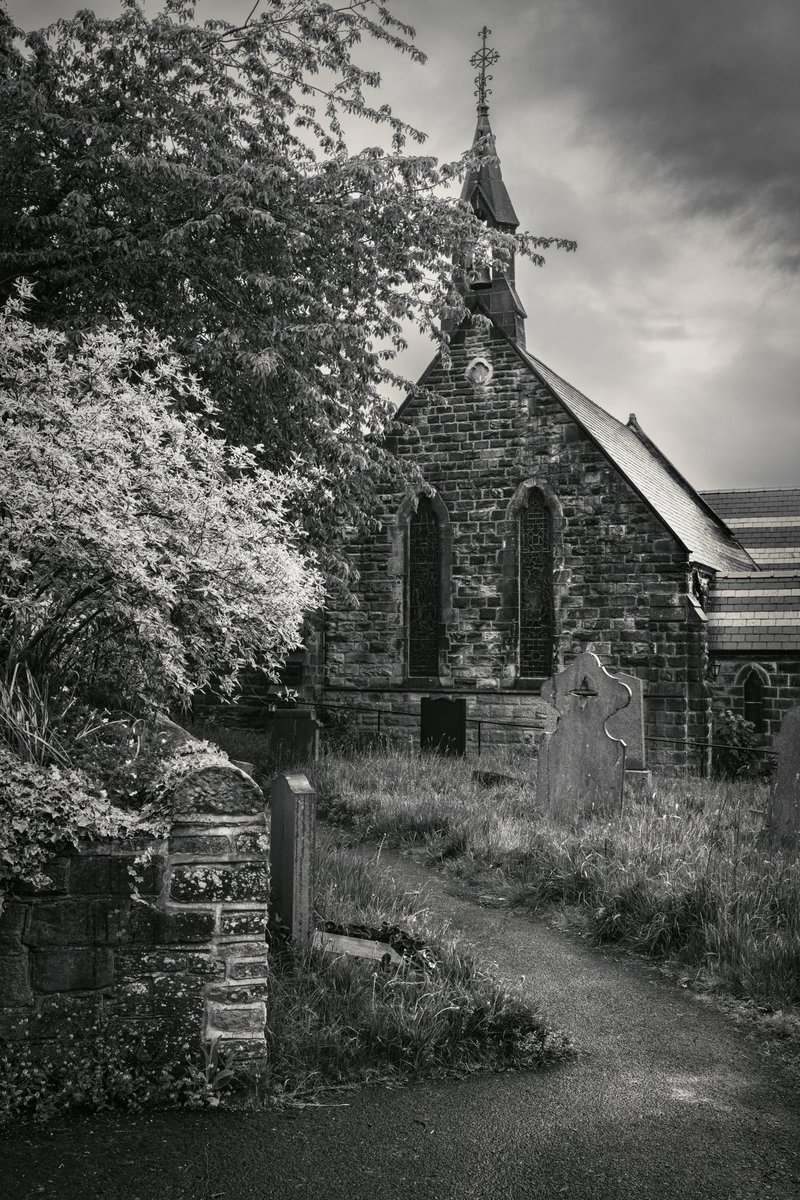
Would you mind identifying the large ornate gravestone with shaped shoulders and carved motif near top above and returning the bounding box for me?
[536,652,631,821]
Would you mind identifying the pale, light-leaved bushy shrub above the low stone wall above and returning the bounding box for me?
[0,285,321,704]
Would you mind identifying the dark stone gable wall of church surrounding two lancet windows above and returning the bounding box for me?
[315,319,710,769]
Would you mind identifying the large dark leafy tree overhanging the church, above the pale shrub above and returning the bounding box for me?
[0,0,569,580]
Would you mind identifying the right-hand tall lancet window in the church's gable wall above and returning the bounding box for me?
[517,488,554,677]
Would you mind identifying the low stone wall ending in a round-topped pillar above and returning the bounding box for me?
[0,764,270,1060]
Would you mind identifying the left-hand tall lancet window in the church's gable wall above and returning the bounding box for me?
[408,496,441,676]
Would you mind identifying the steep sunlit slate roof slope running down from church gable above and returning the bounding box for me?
[517,347,754,572]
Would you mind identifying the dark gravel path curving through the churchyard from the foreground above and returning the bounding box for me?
[0,835,800,1200]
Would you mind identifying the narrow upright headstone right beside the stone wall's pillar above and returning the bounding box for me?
[270,775,317,946]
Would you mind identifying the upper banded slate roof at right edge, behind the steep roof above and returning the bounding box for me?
[703,487,800,571]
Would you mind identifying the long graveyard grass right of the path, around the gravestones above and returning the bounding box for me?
[308,749,800,1012]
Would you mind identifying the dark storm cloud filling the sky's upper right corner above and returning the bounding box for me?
[519,0,800,269]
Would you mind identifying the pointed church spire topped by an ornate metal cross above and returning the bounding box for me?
[461,25,525,346]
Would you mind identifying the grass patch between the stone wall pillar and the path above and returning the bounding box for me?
[260,838,571,1105]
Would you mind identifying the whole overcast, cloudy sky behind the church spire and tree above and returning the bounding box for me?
[8,0,800,490]
